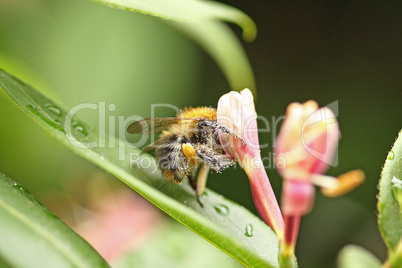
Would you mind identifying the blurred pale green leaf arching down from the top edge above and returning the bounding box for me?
[93,0,257,93]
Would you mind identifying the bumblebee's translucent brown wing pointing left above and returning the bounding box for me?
[127,117,200,135]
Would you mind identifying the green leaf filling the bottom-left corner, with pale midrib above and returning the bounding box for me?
[0,173,109,268]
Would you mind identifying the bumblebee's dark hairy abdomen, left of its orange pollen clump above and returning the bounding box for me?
[155,135,191,182]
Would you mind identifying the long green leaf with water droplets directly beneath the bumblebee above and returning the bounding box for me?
[0,70,278,267]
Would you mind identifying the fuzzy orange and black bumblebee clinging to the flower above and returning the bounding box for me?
[127,107,244,205]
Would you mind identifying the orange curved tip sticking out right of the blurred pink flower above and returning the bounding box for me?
[321,169,366,197]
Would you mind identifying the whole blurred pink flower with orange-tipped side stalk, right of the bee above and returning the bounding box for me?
[275,101,364,258]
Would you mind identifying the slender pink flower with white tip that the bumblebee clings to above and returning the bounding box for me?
[217,89,284,239]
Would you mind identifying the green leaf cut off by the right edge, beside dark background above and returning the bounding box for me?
[377,131,402,253]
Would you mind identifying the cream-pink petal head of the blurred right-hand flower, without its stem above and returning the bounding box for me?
[275,101,340,182]
